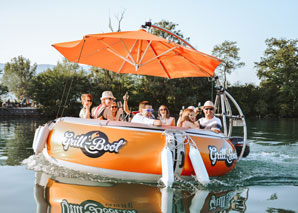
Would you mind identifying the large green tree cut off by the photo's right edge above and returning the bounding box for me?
[255,38,298,117]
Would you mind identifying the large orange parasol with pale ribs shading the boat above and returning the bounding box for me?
[53,27,220,78]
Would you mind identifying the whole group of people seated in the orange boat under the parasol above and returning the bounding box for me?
[80,91,222,133]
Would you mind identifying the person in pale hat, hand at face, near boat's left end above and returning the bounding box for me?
[92,91,116,120]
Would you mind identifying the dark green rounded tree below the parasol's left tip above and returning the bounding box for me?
[28,59,90,117]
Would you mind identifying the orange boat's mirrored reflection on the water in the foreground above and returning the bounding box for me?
[34,172,248,213]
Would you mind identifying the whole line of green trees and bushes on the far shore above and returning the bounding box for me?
[0,21,298,118]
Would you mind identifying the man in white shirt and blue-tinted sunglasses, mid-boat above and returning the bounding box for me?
[131,101,161,126]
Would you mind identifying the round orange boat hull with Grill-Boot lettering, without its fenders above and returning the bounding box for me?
[44,119,237,181]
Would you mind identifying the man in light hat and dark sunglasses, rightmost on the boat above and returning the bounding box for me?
[199,101,222,133]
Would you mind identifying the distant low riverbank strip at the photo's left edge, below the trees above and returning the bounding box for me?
[0,107,40,117]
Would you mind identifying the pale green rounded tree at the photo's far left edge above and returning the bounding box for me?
[2,56,37,99]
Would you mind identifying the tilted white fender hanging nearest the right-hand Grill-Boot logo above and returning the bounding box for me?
[189,146,210,185]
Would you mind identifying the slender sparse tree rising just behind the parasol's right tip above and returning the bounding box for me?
[212,41,245,88]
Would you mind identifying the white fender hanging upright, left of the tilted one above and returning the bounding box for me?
[161,147,174,187]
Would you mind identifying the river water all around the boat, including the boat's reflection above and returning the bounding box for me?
[0,118,298,213]
